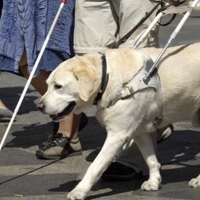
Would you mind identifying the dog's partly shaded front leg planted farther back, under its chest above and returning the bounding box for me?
[135,133,162,191]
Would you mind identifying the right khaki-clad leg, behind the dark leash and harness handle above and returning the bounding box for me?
[117,0,159,48]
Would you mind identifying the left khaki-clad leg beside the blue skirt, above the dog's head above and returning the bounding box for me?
[74,0,118,55]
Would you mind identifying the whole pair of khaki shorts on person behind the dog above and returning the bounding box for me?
[74,0,158,54]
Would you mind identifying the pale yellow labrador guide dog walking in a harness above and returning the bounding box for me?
[38,43,200,200]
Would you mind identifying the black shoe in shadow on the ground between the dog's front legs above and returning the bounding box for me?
[101,162,138,181]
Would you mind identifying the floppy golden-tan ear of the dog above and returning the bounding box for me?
[74,68,99,102]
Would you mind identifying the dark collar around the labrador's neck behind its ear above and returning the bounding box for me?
[93,54,109,105]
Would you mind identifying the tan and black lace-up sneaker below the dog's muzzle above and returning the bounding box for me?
[35,133,82,160]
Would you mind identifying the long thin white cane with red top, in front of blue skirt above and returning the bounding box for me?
[0,0,67,151]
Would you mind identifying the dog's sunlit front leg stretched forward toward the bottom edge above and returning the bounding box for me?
[67,133,126,200]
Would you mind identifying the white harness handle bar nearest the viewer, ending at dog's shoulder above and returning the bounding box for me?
[143,0,199,82]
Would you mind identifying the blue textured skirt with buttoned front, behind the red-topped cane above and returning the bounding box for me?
[0,0,75,75]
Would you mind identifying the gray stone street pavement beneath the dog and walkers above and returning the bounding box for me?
[0,7,200,200]
